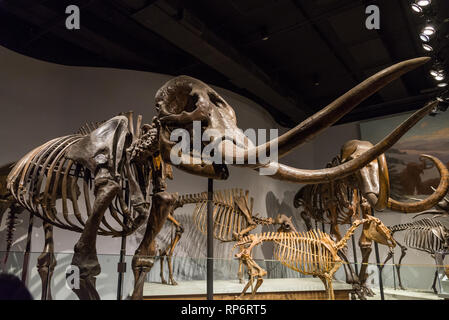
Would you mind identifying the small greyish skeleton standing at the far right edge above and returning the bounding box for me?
[383,218,449,293]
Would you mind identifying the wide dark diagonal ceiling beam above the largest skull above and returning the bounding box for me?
[133,0,312,123]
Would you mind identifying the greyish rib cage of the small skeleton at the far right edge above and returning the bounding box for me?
[389,218,447,254]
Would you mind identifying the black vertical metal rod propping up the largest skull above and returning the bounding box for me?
[207,178,214,300]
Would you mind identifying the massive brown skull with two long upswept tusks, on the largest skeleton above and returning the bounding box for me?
[156,58,436,183]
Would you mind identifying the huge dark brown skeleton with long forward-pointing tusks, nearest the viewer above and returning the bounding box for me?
[0,58,440,299]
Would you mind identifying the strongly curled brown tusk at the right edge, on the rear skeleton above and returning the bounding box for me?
[388,155,449,213]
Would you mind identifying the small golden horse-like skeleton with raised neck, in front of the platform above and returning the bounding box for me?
[235,212,395,300]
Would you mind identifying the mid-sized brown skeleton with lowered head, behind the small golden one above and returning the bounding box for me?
[160,189,295,284]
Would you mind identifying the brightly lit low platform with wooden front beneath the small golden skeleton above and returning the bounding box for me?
[143,278,352,300]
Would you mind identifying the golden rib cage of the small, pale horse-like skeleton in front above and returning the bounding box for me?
[237,230,336,276]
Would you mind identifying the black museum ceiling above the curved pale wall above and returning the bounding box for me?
[0,0,449,126]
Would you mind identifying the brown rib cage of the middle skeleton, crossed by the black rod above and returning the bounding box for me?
[179,189,266,242]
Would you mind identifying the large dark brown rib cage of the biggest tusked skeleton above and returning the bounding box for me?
[8,131,145,236]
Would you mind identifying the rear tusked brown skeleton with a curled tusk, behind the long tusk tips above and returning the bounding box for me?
[294,137,449,299]
